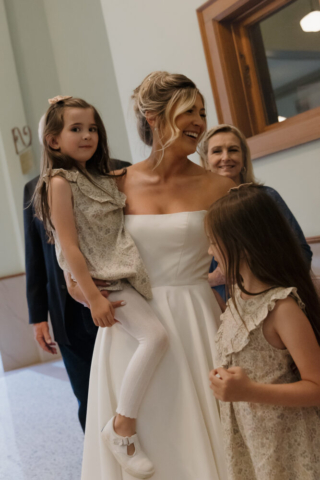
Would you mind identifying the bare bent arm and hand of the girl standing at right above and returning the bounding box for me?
[210,298,320,407]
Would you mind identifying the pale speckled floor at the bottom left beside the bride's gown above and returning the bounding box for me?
[0,361,83,480]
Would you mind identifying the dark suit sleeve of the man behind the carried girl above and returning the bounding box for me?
[23,184,48,323]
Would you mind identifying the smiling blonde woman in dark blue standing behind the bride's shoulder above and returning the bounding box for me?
[199,124,312,305]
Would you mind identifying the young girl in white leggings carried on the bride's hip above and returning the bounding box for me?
[35,97,167,478]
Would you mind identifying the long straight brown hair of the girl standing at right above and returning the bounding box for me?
[205,185,320,344]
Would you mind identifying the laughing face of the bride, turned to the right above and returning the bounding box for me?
[164,94,207,156]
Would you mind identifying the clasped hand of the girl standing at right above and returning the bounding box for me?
[209,367,254,402]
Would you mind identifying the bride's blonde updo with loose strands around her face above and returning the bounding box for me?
[132,71,204,161]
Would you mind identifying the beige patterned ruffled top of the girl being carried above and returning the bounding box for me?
[52,168,152,299]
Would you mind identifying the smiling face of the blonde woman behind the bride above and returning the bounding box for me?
[207,132,244,185]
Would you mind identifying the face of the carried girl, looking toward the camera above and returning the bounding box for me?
[51,107,99,167]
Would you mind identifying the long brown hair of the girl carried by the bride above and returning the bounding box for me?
[32,97,121,243]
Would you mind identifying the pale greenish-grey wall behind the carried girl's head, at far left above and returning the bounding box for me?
[0,0,131,277]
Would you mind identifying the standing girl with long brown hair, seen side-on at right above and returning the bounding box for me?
[206,185,320,480]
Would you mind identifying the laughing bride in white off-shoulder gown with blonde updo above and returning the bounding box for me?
[82,72,233,480]
